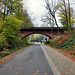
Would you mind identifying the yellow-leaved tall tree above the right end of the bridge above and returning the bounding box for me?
[58,0,75,30]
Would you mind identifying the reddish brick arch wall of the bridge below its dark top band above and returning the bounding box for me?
[20,31,65,38]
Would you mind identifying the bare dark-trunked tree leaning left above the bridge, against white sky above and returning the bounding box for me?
[45,0,60,34]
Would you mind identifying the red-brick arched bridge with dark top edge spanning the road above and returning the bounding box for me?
[20,27,67,38]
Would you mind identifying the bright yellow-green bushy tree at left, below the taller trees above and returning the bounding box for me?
[0,15,22,48]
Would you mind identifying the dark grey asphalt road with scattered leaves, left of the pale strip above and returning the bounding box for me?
[0,44,54,75]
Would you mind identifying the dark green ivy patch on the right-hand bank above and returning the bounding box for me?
[55,31,75,50]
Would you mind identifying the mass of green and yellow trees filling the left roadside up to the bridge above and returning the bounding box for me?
[0,0,33,50]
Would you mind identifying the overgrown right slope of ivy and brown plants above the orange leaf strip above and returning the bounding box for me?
[54,30,75,55]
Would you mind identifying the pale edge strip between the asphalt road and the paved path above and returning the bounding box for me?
[41,45,61,75]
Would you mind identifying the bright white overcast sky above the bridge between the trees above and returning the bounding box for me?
[23,0,75,27]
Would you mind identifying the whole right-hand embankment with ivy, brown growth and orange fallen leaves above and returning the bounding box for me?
[45,29,75,61]
